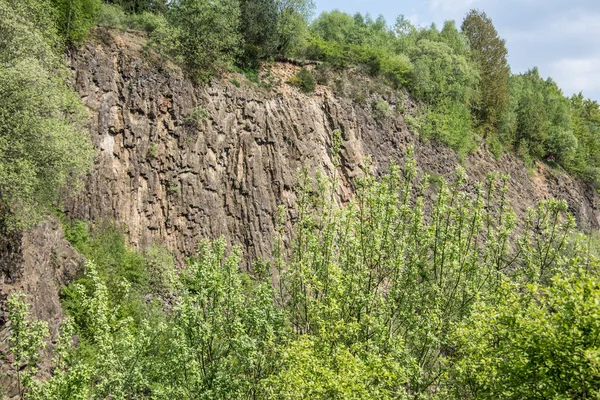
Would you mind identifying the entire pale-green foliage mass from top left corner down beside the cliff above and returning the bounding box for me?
[0,0,93,229]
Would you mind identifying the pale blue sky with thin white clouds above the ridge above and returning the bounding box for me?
[314,0,600,101]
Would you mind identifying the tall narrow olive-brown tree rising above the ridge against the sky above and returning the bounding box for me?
[461,10,510,132]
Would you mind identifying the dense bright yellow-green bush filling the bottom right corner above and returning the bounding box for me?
[451,271,600,399]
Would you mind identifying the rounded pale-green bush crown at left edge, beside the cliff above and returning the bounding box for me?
[0,59,94,228]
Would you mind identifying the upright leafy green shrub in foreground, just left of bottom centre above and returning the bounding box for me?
[157,240,282,399]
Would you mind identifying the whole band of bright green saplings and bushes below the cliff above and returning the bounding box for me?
[11,155,600,399]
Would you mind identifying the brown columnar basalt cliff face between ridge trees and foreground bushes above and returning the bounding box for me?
[67,31,600,266]
